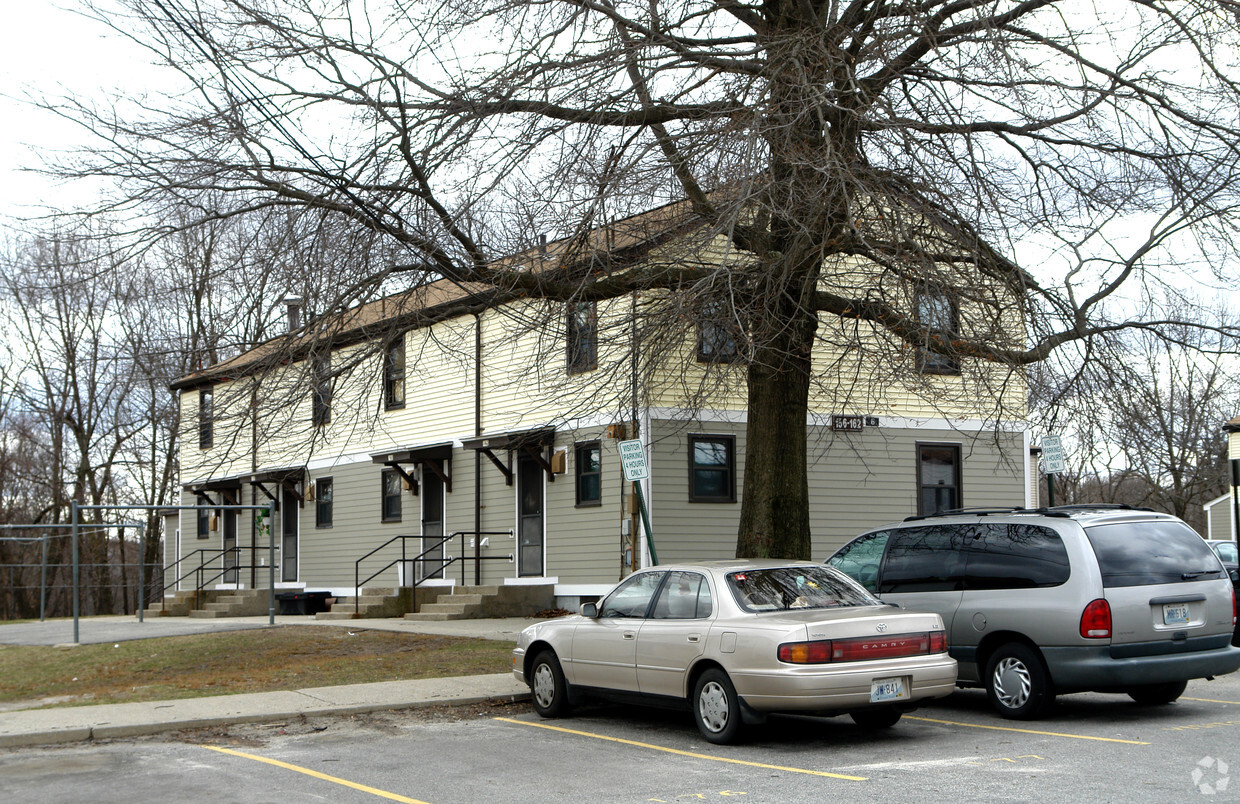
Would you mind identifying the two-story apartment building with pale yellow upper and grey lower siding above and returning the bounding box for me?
[167,202,1037,605]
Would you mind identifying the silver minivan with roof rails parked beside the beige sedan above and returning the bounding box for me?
[827,505,1240,720]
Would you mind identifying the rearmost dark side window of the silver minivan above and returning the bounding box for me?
[965,525,1070,589]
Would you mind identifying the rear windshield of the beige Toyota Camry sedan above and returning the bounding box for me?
[728,567,883,612]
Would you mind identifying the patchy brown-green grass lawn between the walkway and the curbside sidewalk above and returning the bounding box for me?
[0,625,512,706]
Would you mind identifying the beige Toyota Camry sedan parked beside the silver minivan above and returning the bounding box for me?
[512,560,956,743]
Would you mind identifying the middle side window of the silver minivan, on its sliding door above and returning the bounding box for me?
[878,525,967,594]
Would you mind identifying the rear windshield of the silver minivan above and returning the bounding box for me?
[1085,521,1223,587]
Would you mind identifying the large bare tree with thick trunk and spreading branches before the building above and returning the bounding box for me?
[61,0,1240,557]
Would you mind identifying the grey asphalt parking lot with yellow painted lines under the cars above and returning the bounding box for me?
[0,675,1240,804]
